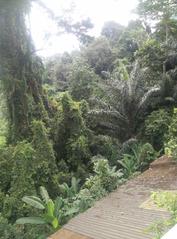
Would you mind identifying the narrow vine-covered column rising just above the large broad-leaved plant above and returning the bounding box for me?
[32,121,58,196]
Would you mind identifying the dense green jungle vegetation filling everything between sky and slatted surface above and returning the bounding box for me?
[0,0,177,239]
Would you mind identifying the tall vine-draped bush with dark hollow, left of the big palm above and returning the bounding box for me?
[52,93,91,181]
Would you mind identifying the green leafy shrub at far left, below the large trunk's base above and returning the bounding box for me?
[2,141,36,222]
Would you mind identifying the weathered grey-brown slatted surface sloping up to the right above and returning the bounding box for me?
[50,156,177,239]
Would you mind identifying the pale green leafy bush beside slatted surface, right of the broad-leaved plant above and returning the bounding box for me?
[54,157,123,224]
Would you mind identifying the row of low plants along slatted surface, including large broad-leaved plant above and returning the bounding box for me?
[17,157,123,228]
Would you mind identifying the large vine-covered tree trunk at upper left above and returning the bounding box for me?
[0,0,47,142]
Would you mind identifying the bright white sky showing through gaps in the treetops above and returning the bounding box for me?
[30,0,137,57]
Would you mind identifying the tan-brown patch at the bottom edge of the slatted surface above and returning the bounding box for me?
[48,229,91,239]
